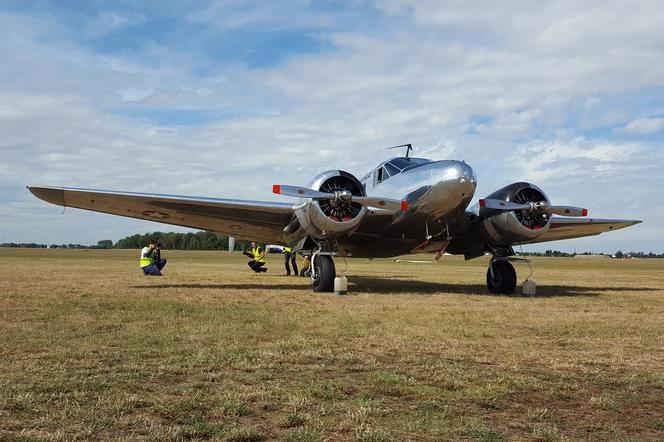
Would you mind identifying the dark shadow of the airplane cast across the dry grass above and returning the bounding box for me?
[131,275,658,297]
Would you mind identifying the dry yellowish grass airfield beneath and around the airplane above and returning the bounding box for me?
[0,249,664,441]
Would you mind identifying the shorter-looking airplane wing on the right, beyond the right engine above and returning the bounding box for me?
[521,217,641,244]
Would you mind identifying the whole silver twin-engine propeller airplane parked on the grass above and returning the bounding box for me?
[28,145,640,293]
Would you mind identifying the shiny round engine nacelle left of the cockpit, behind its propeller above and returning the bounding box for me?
[295,170,367,240]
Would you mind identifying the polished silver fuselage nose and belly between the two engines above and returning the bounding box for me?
[339,160,477,257]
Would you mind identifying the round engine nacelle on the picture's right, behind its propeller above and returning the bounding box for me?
[479,183,551,246]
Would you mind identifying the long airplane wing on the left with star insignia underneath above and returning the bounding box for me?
[28,186,294,243]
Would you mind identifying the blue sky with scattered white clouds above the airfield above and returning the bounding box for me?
[0,0,664,252]
